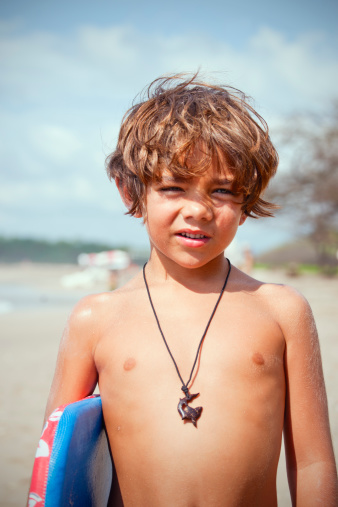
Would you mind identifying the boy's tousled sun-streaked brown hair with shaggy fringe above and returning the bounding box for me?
[106,74,278,218]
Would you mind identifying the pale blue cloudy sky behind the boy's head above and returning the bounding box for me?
[0,0,338,253]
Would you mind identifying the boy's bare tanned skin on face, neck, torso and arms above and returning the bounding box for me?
[46,168,337,507]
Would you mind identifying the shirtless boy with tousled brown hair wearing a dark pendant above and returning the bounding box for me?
[46,76,337,507]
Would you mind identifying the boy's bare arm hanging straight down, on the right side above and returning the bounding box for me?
[278,287,338,507]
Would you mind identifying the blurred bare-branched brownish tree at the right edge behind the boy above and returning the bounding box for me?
[267,102,338,266]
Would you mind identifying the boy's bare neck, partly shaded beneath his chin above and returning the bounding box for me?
[146,249,229,293]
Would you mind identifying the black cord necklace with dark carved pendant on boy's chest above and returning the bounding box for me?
[143,259,231,427]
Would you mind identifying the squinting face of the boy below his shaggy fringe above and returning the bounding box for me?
[145,167,246,268]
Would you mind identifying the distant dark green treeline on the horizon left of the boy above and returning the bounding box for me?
[0,237,126,264]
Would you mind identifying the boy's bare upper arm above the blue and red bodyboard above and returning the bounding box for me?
[45,296,99,421]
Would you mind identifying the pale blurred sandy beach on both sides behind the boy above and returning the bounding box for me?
[0,264,338,507]
